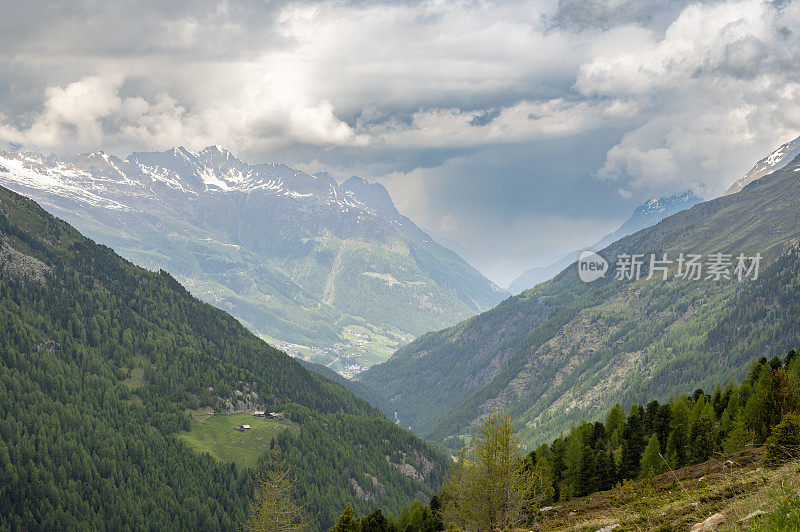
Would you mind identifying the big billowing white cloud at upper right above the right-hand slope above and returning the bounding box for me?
[576,0,800,197]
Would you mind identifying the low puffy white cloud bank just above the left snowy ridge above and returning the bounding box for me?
[0,75,368,150]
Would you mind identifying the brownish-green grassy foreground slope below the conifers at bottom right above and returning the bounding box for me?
[533,449,800,532]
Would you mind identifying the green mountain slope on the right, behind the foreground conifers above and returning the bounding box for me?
[362,153,800,445]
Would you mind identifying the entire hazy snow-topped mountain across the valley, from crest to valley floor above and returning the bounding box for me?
[0,146,507,372]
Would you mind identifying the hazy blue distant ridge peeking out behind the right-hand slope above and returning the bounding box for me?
[508,190,701,294]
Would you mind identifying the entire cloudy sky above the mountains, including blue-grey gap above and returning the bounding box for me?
[0,0,800,286]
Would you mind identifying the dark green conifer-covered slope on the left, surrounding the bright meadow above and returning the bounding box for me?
[0,188,444,530]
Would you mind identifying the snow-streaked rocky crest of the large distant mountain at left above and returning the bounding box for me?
[0,146,400,217]
